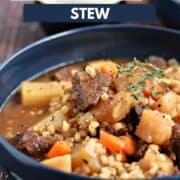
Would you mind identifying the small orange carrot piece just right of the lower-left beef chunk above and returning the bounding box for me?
[47,141,71,158]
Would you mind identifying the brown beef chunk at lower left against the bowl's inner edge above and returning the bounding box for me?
[11,130,56,159]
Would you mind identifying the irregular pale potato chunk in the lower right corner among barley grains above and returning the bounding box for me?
[139,145,174,175]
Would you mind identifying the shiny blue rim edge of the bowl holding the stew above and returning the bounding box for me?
[0,24,180,180]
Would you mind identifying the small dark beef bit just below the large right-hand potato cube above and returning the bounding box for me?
[133,140,148,161]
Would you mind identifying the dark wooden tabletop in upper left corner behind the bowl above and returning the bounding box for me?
[0,0,45,63]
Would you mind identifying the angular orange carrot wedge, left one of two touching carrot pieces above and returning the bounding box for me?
[100,130,125,153]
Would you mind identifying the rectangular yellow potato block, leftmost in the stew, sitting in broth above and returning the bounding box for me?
[21,81,63,107]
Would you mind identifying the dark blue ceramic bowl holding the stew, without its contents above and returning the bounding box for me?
[0,25,180,180]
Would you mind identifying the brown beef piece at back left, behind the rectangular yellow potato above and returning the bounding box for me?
[51,65,84,81]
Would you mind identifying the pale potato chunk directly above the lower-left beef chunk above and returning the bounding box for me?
[33,111,66,134]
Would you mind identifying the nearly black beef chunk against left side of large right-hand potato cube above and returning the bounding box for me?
[125,104,148,132]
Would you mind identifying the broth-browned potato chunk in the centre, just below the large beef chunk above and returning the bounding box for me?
[92,92,132,123]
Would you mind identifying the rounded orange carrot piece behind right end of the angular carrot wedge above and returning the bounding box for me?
[119,136,136,156]
